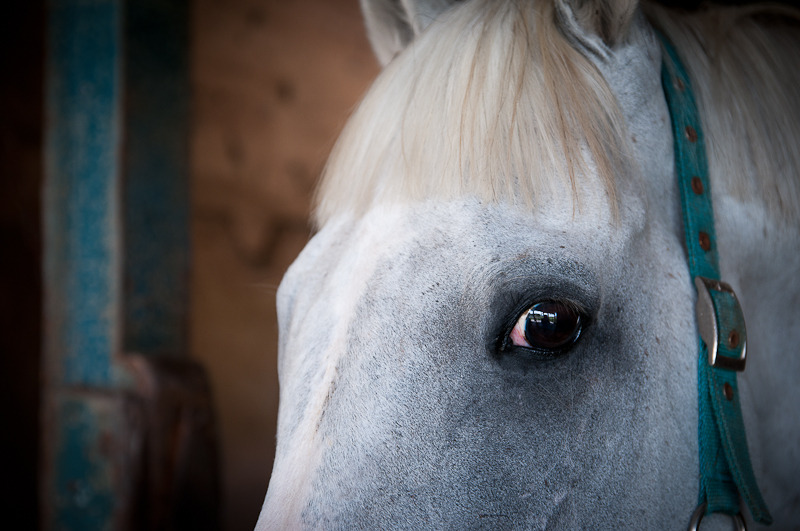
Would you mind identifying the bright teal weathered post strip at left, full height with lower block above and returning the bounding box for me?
[41,0,122,529]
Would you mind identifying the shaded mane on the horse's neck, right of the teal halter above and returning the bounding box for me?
[646,4,800,221]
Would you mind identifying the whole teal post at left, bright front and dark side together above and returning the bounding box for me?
[40,0,208,530]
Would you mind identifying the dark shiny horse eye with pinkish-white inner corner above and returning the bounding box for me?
[509,301,583,352]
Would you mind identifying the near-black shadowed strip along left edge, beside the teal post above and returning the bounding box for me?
[0,1,44,529]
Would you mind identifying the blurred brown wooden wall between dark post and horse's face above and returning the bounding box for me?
[190,0,378,530]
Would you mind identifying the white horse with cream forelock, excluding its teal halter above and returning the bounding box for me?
[257,0,800,529]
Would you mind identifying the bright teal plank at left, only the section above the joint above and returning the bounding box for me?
[44,0,122,387]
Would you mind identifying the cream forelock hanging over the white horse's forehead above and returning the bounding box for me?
[316,0,629,225]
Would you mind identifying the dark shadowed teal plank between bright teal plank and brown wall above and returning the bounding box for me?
[123,0,191,355]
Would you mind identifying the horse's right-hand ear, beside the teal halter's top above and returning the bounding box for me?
[556,0,639,55]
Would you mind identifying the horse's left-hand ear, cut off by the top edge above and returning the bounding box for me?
[360,0,458,65]
